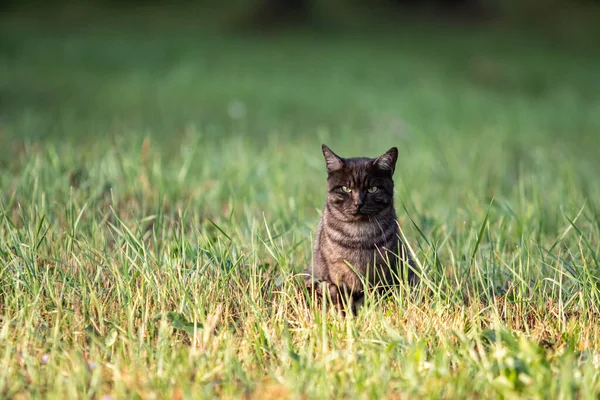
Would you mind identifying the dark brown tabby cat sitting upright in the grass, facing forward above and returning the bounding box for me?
[305,145,416,306]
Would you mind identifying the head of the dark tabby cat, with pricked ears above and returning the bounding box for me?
[322,145,398,220]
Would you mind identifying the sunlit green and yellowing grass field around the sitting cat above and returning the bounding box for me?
[0,7,600,399]
